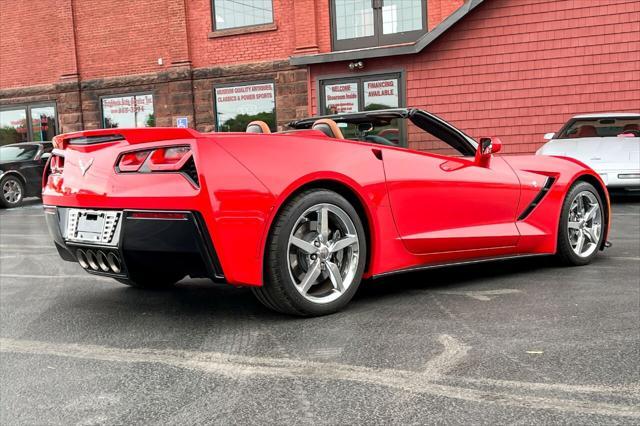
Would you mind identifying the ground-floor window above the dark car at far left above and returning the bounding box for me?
[0,104,59,145]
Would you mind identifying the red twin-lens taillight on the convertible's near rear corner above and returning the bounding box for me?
[116,145,199,187]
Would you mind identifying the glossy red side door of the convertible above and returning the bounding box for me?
[384,111,520,254]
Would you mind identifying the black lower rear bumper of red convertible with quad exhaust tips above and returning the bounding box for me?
[45,206,225,282]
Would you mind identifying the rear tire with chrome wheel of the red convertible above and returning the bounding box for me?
[252,189,367,316]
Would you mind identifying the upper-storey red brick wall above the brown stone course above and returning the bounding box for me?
[0,0,463,88]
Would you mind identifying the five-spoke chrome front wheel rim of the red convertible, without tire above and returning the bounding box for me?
[567,191,602,257]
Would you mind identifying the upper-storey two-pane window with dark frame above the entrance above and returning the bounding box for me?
[331,0,427,50]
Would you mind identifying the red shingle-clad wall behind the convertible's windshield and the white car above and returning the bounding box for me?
[311,0,640,153]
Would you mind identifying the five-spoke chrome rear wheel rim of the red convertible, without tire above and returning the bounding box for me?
[287,203,360,304]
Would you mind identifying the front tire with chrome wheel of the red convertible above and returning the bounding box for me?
[556,181,606,266]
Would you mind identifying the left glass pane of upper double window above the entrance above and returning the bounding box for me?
[335,0,374,40]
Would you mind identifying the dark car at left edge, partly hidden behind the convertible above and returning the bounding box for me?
[0,142,53,207]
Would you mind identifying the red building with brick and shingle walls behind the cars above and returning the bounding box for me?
[0,0,640,152]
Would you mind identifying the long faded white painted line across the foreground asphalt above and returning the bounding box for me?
[0,336,640,418]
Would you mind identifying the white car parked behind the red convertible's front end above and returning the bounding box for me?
[536,112,640,191]
